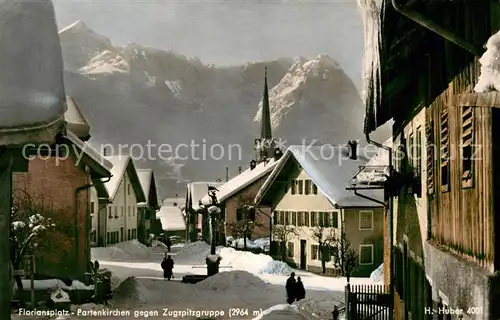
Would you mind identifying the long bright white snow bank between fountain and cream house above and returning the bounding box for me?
[218,248,294,275]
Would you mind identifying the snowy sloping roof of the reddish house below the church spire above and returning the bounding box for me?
[200,159,280,203]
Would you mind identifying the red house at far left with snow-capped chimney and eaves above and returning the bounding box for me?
[13,97,113,278]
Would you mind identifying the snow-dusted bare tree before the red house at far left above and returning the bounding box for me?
[10,191,55,306]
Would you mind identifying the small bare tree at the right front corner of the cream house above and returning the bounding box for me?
[331,232,358,283]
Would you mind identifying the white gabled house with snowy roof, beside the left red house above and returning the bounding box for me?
[99,155,146,245]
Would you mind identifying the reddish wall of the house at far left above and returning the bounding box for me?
[13,157,90,277]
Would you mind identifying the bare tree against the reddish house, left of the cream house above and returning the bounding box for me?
[227,197,263,249]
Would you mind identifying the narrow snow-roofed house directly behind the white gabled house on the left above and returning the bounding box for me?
[137,169,160,244]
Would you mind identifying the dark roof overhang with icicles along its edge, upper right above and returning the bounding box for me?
[358,0,493,134]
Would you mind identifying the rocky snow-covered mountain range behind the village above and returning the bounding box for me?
[60,21,378,196]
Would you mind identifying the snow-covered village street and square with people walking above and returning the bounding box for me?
[13,241,373,320]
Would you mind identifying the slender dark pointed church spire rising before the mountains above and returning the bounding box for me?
[257,66,275,163]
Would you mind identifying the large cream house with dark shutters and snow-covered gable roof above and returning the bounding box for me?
[254,146,384,276]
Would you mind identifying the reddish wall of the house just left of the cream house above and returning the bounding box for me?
[226,174,270,240]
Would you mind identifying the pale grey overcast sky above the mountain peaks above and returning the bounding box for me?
[54,0,363,87]
